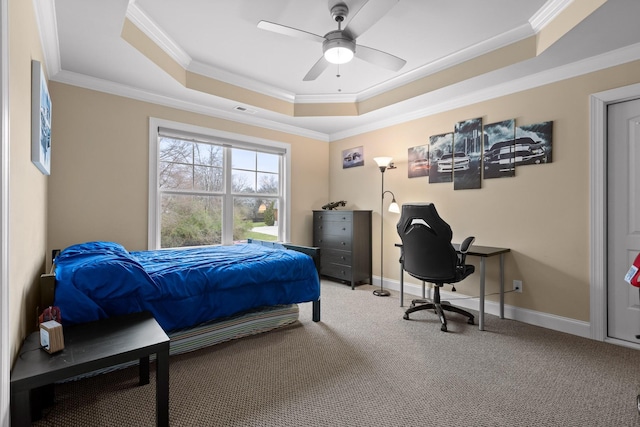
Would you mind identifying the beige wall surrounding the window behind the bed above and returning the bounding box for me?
[47,82,329,256]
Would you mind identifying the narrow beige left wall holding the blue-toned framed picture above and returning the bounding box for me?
[8,0,48,362]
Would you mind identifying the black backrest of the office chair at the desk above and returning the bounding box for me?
[397,203,458,283]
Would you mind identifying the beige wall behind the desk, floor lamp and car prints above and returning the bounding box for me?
[329,62,640,321]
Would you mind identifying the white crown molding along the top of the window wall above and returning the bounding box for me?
[51,70,329,142]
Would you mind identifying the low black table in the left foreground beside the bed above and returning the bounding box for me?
[11,312,169,426]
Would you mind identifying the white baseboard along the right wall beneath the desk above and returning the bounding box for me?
[374,278,591,338]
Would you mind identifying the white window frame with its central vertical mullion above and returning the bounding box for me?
[147,117,291,250]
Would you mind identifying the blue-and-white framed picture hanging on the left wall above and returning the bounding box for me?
[31,61,51,175]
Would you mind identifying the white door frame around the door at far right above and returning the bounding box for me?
[589,83,640,349]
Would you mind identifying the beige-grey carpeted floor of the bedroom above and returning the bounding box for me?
[34,281,640,427]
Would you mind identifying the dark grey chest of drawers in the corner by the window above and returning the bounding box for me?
[313,210,373,289]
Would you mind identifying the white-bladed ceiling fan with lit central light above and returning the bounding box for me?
[258,0,407,81]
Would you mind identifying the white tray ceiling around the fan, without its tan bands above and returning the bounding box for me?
[40,0,640,141]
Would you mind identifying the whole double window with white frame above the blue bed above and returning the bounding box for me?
[149,119,290,249]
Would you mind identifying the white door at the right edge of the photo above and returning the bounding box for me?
[607,100,640,343]
